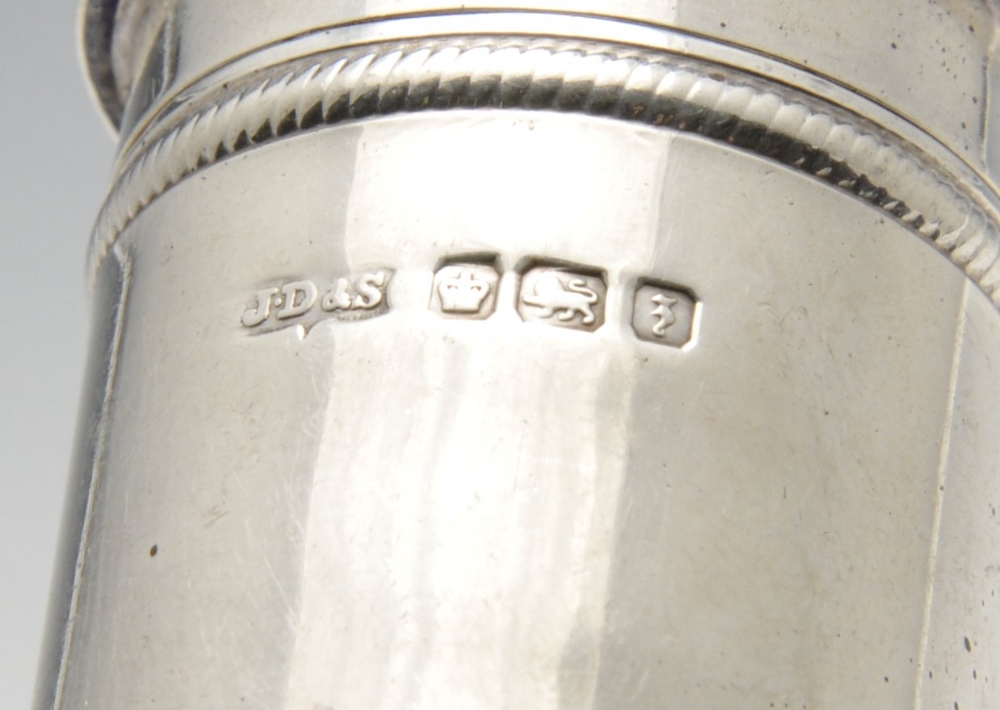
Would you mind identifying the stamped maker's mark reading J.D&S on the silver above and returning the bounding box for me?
[240,269,393,334]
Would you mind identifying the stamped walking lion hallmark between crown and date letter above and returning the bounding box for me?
[517,266,607,332]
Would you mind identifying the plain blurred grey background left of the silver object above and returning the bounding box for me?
[0,0,114,710]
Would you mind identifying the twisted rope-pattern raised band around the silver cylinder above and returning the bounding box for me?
[90,37,1000,307]
